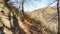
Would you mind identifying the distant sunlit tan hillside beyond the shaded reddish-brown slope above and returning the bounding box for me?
[31,7,58,32]
